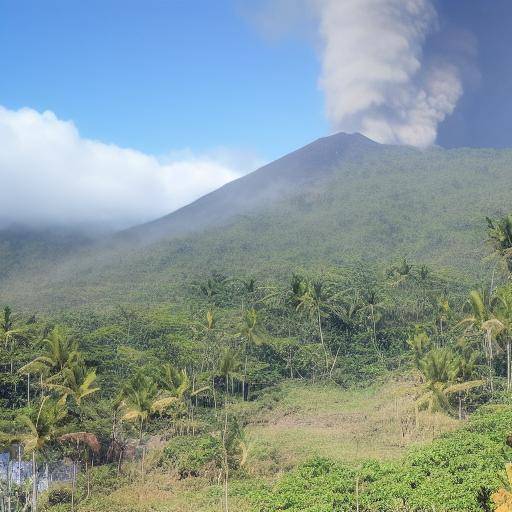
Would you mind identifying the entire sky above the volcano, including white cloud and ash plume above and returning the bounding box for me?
[0,0,512,227]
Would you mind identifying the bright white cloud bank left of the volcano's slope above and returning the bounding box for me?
[0,107,256,227]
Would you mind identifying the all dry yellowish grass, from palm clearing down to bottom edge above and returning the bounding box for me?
[59,376,460,512]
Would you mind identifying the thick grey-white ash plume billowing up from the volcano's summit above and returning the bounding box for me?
[313,0,463,147]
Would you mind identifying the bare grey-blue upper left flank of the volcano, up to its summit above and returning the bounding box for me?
[120,133,379,243]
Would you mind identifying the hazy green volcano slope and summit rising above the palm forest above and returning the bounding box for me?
[1,134,512,306]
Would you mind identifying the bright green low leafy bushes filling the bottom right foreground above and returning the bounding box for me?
[251,406,512,512]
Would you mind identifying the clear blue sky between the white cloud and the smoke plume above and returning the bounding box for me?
[0,0,327,158]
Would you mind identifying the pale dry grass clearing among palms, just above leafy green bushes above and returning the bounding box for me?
[240,377,460,470]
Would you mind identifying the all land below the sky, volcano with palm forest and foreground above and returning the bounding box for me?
[0,135,512,512]
